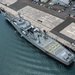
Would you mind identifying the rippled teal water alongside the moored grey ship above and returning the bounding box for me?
[0,14,75,75]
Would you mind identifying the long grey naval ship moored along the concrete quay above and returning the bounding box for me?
[1,9,74,65]
